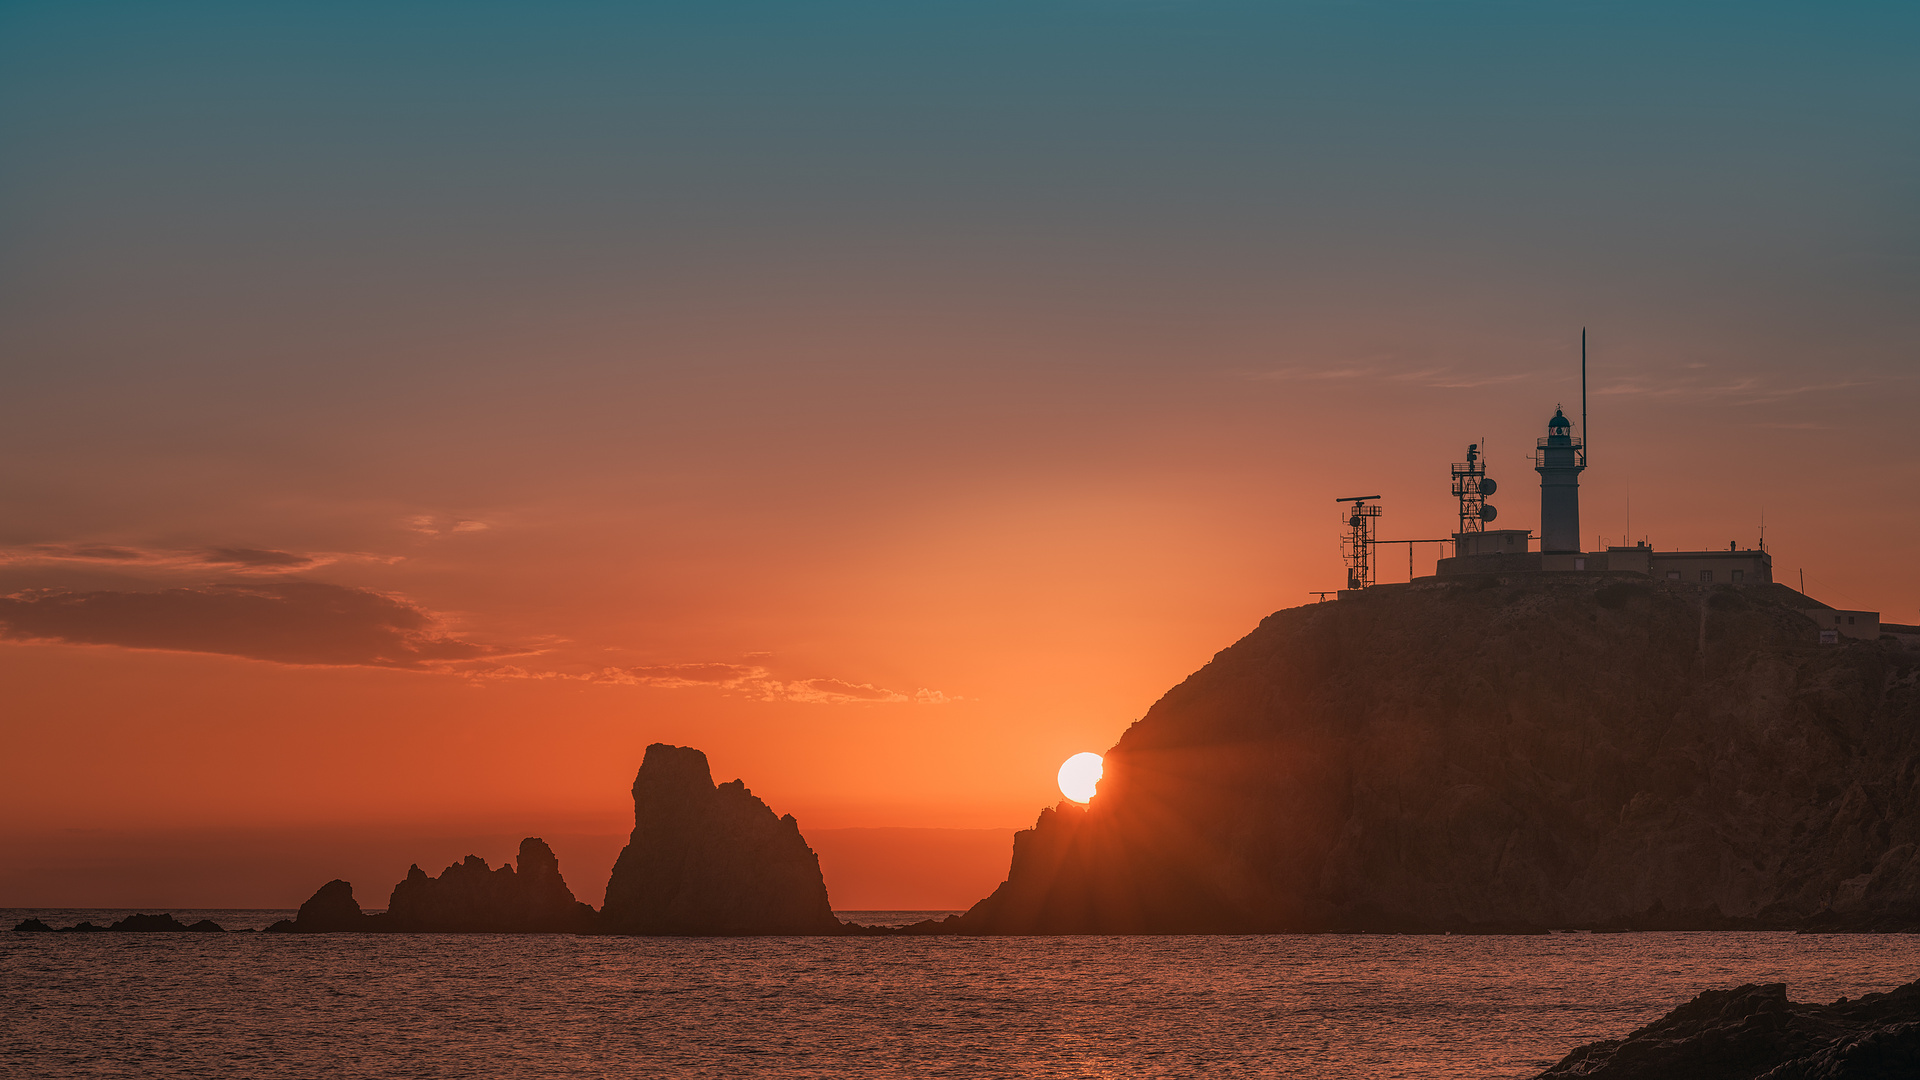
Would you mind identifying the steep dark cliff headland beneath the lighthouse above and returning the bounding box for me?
[958,575,1920,932]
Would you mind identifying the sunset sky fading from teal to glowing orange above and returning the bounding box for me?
[0,0,1920,907]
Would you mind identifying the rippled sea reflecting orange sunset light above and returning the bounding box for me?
[0,909,1920,1080]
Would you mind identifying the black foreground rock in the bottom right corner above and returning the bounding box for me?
[1540,982,1920,1080]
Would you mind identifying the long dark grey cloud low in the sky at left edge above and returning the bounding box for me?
[0,582,499,671]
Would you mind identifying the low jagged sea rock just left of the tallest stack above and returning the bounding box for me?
[380,836,595,934]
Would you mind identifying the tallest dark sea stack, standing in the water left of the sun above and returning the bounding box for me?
[601,744,843,936]
